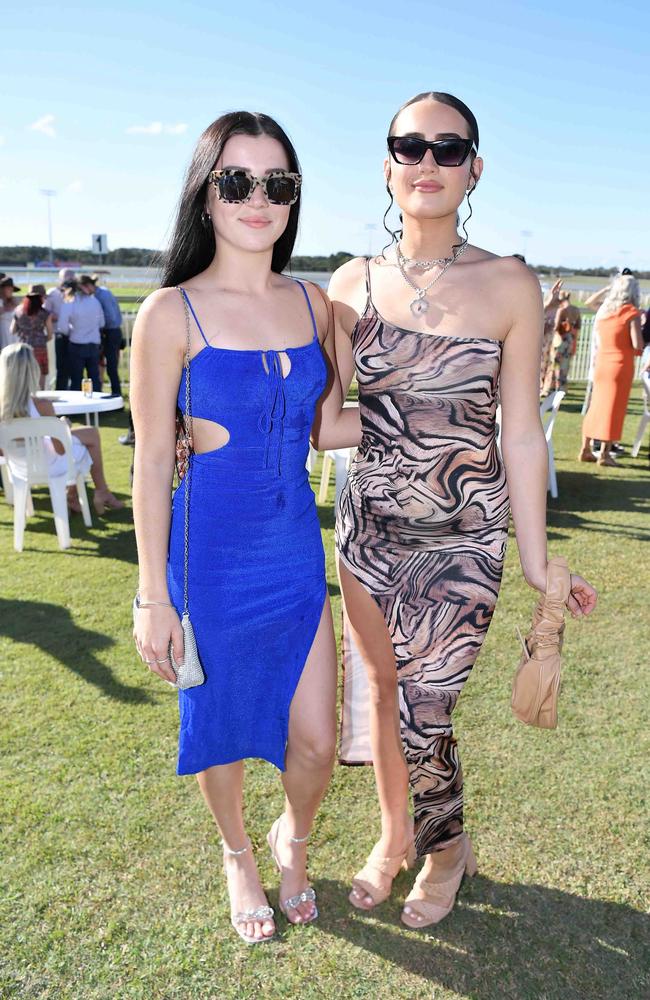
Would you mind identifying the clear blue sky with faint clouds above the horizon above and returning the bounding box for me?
[0,0,650,268]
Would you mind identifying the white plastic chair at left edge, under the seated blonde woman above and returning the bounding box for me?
[0,417,92,552]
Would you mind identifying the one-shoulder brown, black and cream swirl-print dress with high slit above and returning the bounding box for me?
[337,262,509,856]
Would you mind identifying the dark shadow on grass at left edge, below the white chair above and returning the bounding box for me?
[0,598,153,704]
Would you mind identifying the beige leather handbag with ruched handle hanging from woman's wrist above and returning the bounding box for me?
[512,556,571,729]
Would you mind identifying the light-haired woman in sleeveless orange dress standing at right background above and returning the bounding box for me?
[578,275,643,465]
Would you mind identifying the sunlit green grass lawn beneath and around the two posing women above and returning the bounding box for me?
[0,384,650,1000]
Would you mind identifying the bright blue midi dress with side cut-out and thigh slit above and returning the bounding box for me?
[167,284,326,774]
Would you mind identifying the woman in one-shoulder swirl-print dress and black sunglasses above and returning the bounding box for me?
[330,93,596,927]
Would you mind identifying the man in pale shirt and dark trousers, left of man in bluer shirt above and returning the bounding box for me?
[58,274,104,392]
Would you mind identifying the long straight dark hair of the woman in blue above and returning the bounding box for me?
[159,111,300,288]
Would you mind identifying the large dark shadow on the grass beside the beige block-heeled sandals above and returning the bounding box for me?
[315,875,650,1000]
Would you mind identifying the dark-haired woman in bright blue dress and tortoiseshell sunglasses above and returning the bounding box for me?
[131,112,360,943]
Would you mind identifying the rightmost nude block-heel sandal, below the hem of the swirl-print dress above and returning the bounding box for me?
[402,833,478,930]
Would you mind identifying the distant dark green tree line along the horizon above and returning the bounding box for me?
[0,246,650,278]
